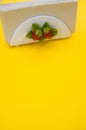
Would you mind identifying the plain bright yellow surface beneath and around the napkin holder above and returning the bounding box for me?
[0,0,86,130]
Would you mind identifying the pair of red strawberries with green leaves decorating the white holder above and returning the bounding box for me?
[26,22,57,41]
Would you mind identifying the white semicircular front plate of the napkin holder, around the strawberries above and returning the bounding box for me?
[10,16,71,46]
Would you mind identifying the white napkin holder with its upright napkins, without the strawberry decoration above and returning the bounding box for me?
[0,0,77,46]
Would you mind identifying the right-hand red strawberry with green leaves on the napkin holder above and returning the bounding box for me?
[42,22,57,39]
